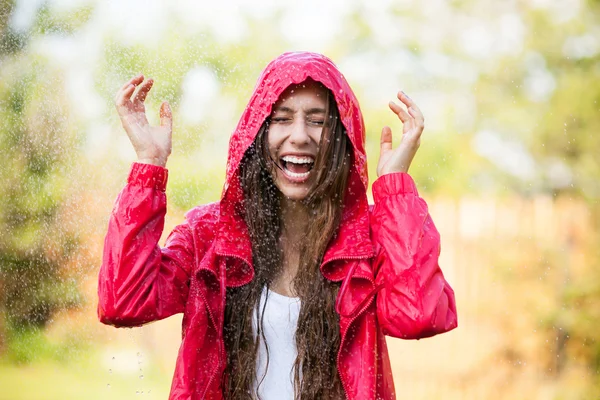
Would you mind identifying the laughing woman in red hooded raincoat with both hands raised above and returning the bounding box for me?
[98,53,457,400]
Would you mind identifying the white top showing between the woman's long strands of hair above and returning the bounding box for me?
[252,288,300,400]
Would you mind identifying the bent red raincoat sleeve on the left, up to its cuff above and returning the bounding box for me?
[98,163,193,326]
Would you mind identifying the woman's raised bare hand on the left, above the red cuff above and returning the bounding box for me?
[115,74,173,167]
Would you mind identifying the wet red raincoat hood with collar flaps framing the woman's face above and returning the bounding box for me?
[215,52,373,286]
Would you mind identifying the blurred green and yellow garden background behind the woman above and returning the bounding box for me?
[0,0,600,400]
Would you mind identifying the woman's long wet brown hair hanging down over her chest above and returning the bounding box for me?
[223,82,352,400]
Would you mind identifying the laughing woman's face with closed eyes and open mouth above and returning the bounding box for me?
[267,81,327,201]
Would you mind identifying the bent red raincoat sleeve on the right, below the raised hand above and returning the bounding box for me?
[371,173,457,339]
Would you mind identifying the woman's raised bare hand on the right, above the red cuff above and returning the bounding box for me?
[377,92,425,176]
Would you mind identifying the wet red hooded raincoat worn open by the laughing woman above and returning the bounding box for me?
[98,53,457,400]
